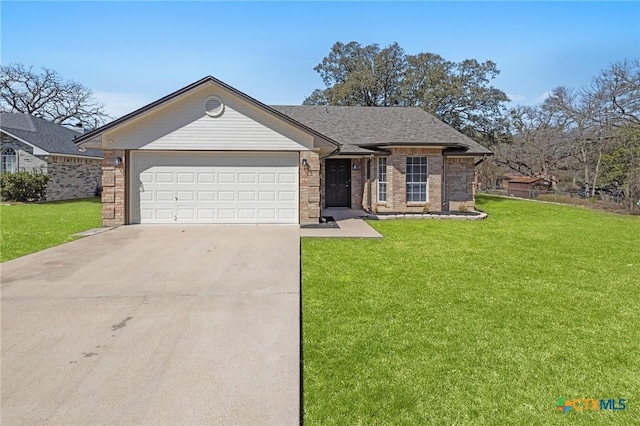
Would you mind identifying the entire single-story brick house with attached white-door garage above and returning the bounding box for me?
[76,77,491,226]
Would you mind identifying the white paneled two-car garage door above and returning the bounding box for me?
[130,151,298,223]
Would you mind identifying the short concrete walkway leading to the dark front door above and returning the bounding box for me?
[300,207,382,238]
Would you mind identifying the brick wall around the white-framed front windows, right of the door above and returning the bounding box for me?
[372,148,443,213]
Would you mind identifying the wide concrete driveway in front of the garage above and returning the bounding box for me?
[0,225,300,425]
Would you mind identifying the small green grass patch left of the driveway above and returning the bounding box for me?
[0,198,102,262]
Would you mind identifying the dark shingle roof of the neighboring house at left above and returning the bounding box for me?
[0,112,102,158]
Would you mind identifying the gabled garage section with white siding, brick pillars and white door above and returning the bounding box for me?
[75,76,339,226]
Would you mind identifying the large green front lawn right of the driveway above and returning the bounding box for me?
[302,196,640,425]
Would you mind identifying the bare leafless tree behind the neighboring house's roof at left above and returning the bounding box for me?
[0,64,110,128]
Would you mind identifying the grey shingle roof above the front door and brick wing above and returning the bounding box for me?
[271,105,491,155]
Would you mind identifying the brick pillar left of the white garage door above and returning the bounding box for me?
[102,149,127,226]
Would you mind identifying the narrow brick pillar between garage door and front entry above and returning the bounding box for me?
[298,151,321,224]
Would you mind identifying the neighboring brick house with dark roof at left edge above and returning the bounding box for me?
[0,112,102,201]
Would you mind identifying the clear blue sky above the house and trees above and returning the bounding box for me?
[0,0,640,117]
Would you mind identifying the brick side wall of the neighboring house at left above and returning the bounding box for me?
[47,155,102,201]
